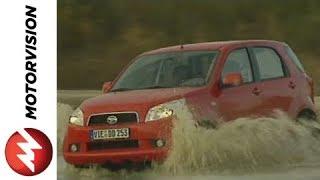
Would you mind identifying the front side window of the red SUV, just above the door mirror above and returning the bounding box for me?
[222,48,253,83]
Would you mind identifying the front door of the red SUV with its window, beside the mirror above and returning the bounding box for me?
[217,48,262,121]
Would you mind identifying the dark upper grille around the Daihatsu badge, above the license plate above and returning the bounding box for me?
[88,112,138,126]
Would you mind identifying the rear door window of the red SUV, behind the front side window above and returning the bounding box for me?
[252,47,285,80]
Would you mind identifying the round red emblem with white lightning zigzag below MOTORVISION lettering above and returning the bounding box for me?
[5,128,52,176]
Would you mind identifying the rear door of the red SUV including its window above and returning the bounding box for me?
[250,47,297,116]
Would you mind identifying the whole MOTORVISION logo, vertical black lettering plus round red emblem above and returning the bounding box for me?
[5,5,52,176]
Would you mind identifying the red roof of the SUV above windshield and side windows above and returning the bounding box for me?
[140,40,285,56]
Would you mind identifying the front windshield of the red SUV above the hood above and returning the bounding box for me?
[111,51,218,91]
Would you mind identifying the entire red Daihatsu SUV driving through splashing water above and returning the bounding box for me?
[63,40,316,165]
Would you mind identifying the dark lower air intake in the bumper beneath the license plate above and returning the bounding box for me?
[87,140,139,151]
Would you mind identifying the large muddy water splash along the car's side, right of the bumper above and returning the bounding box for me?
[162,109,320,174]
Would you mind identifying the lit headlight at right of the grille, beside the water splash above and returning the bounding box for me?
[146,99,186,122]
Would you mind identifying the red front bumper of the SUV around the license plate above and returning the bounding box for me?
[63,118,172,165]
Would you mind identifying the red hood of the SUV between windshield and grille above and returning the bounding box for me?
[80,87,201,117]
